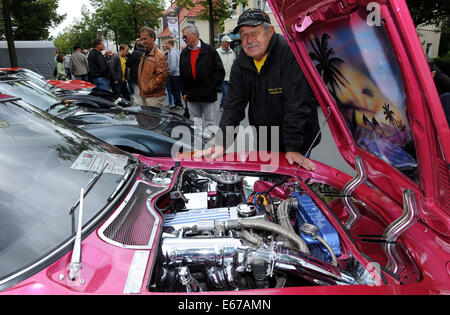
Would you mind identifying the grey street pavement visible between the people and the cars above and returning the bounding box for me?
[165,94,355,176]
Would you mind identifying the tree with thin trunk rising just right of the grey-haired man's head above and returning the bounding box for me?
[175,0,248,45]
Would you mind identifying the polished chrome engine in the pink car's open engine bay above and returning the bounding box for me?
[151,170,370,292]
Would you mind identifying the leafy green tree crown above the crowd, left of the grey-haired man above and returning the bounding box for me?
[90,0,164,44]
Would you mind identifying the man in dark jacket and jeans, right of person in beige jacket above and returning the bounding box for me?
[88,39,111,91]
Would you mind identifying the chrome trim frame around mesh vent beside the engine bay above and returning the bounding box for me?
[98,180,168,250]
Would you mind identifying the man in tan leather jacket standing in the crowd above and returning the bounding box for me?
[138,26,168,107]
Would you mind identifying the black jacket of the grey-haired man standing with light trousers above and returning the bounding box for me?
[180,41,225,102]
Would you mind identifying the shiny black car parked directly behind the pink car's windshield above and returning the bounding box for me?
[0,73,205,157]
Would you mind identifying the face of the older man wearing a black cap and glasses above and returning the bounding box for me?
[239,25,275,60]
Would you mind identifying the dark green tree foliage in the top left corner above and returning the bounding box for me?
[0,0,66,40]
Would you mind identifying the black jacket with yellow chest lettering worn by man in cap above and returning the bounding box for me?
[217,34,320,155]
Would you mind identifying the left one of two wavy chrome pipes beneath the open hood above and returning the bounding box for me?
[341,156,367,230]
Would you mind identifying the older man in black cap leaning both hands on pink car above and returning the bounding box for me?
[196,9,319,170]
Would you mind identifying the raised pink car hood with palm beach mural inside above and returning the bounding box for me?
[269,0,450,236]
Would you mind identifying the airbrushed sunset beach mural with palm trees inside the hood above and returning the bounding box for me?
[306,19,417,181]
